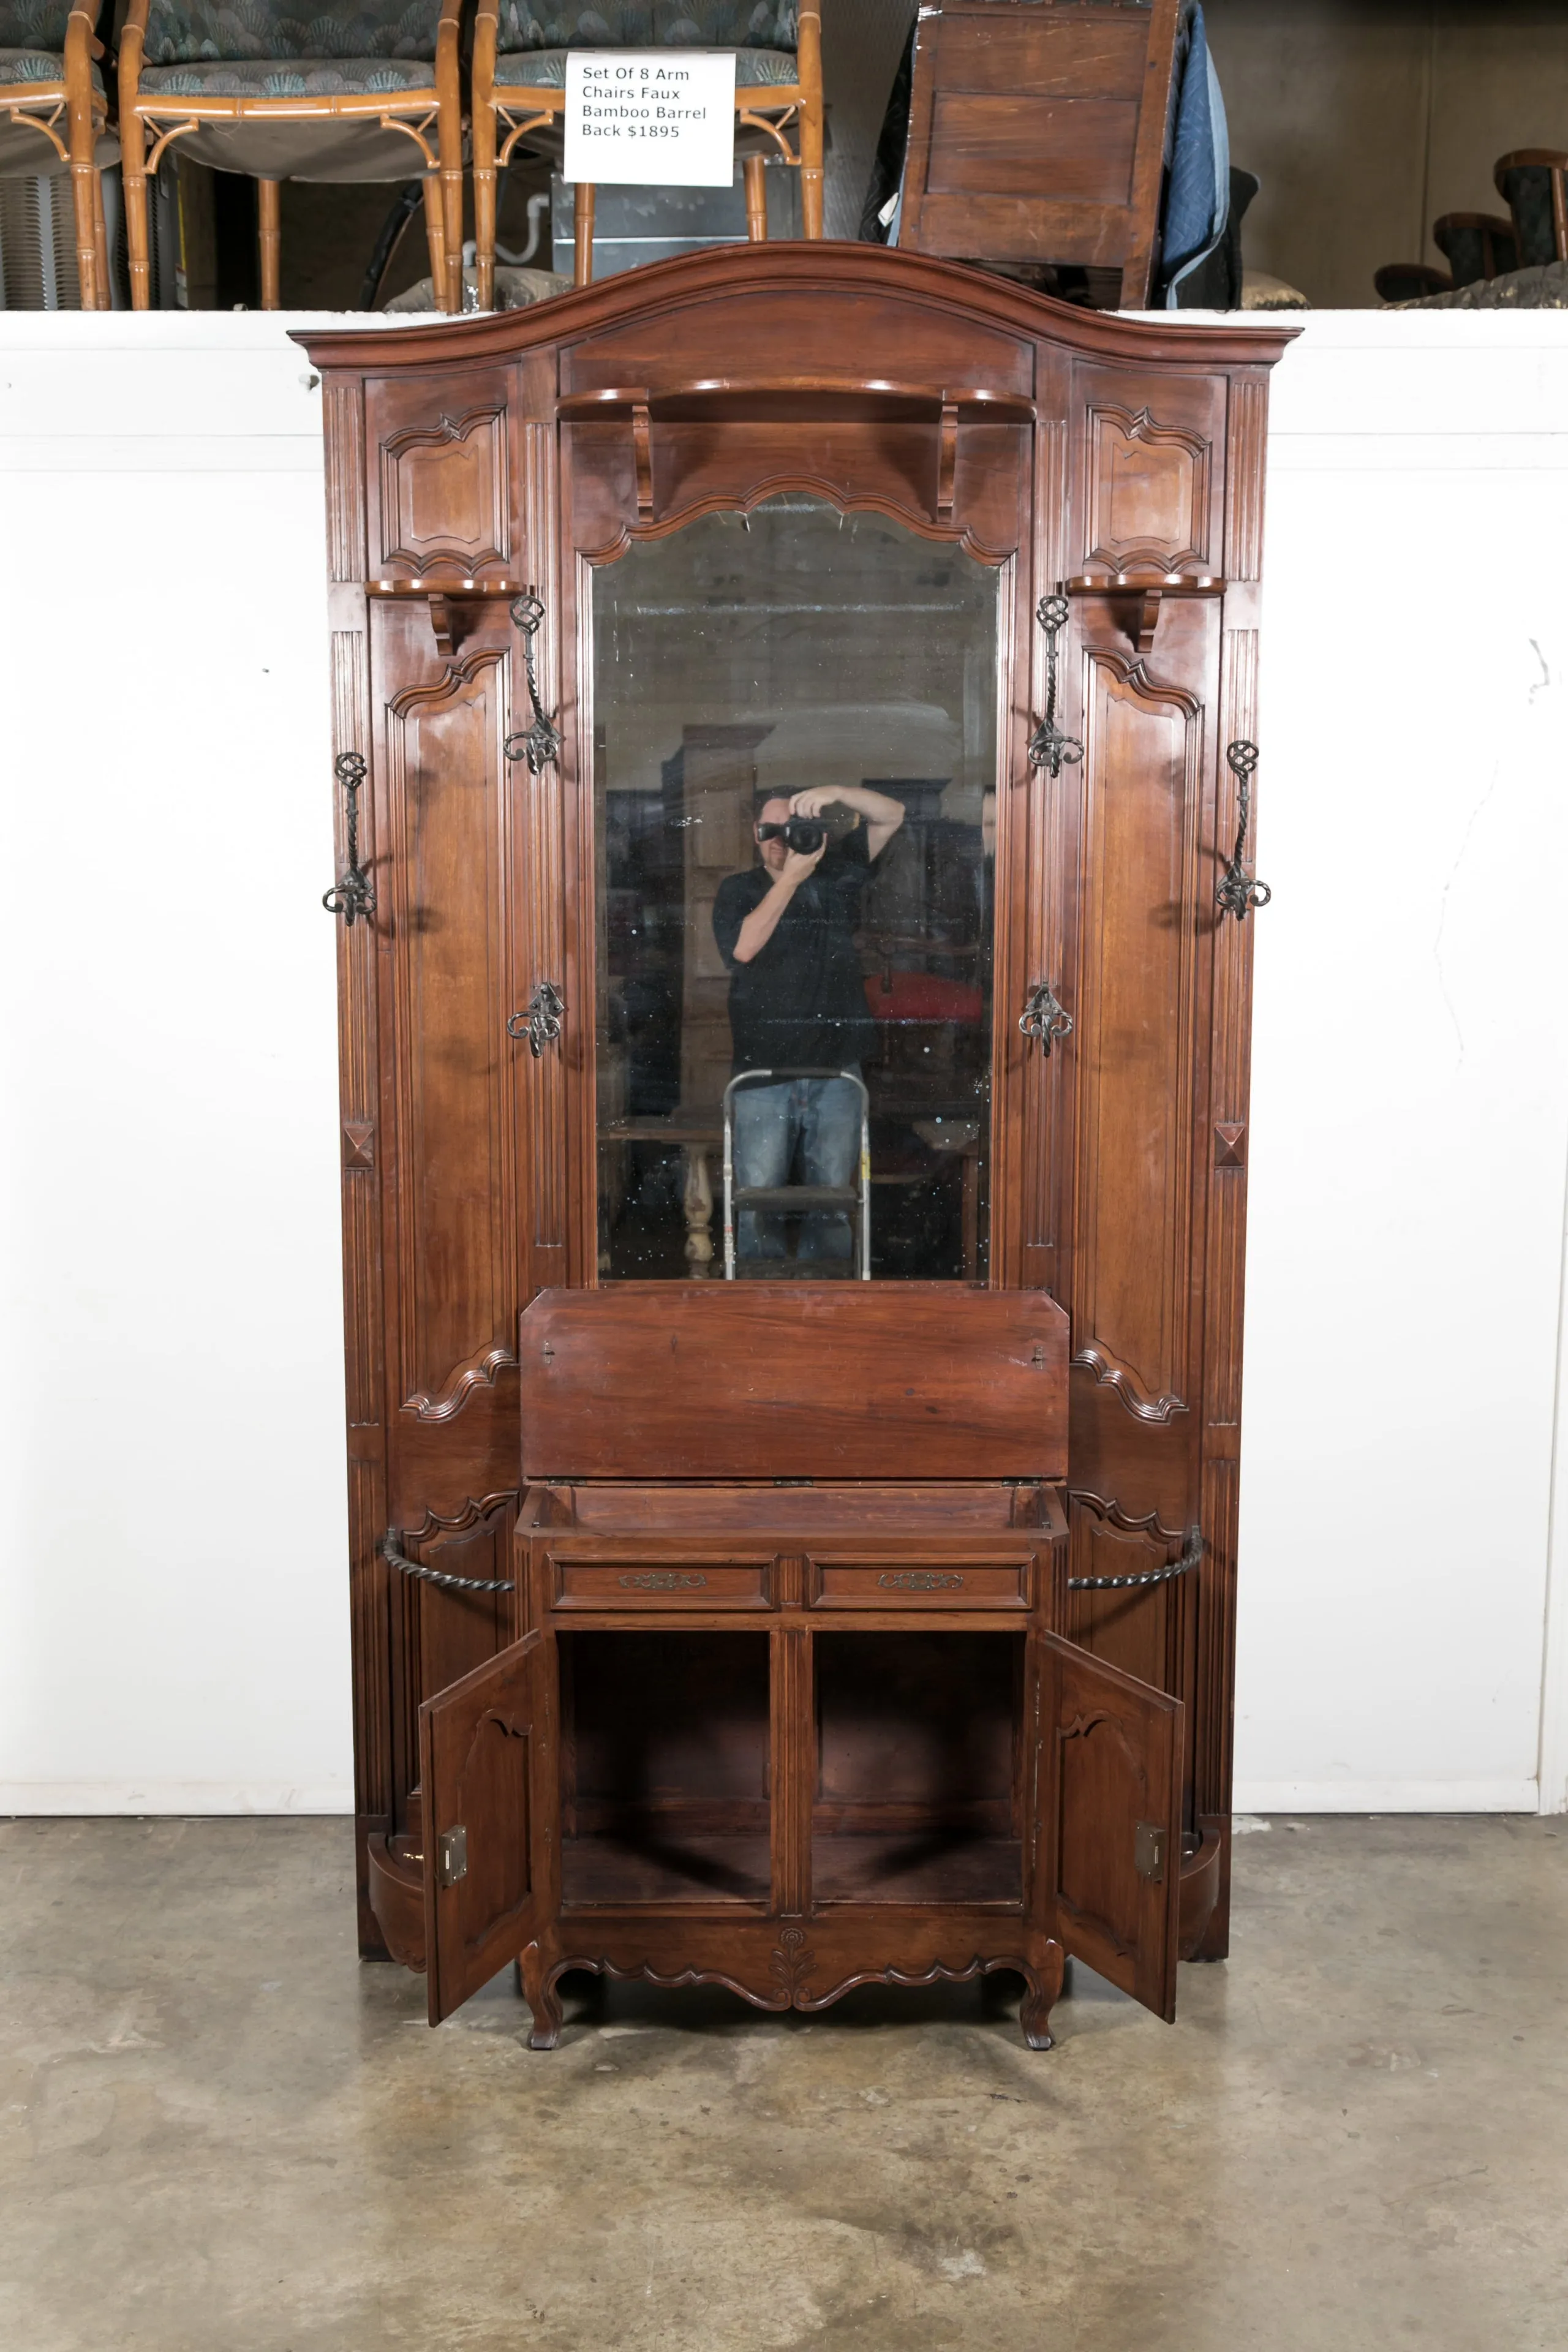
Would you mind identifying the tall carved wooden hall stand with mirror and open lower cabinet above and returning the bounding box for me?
[303,244,1286,2046]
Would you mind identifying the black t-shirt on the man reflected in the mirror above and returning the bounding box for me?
[712,826,877,1075]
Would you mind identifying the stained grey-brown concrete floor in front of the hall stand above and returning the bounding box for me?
[0,1818,1568,2352]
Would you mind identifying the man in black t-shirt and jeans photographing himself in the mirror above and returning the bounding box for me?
[712,786,903,1263]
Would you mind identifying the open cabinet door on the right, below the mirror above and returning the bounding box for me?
[1039,1632,1183,2021]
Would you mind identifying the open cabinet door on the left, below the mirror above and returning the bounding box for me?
[418,1632,548,2025]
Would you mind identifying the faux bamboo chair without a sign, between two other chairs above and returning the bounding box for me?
[120,0,463,311]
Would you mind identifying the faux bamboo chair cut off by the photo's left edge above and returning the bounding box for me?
[0,0,115,311]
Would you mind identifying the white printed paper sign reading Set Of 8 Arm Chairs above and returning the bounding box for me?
[562,50,736,188]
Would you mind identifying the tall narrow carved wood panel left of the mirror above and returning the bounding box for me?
[385,614,519,1420]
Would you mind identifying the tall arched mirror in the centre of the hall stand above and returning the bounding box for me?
[592,496,999,1282]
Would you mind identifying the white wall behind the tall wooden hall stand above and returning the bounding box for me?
[0,313,1568,1814]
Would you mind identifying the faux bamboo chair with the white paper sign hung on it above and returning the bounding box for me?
[472,0,823,311]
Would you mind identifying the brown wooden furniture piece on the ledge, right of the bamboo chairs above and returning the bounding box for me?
[898,0,1180,311]
